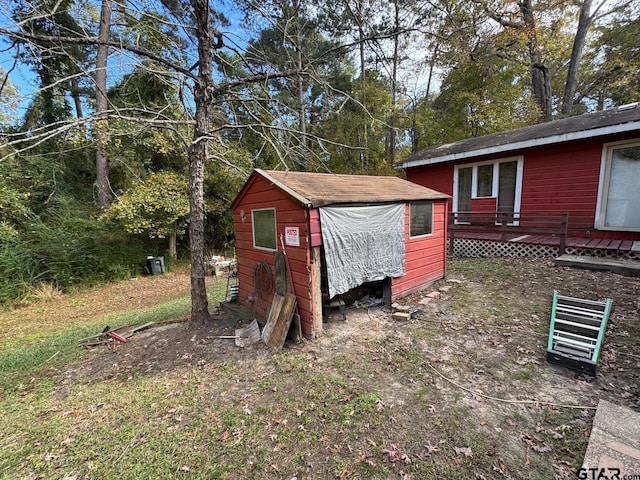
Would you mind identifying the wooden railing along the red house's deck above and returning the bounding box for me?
[449,212,569,255]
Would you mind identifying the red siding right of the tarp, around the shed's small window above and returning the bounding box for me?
[391,200,447,301]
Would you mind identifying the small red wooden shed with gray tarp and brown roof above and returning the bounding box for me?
[232,169,450,338]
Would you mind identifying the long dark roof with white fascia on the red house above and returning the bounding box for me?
[396,102,640,168]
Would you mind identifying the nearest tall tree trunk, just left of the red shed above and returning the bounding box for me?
[188,0,220,323]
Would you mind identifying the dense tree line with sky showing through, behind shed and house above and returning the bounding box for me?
[0,0,640,319]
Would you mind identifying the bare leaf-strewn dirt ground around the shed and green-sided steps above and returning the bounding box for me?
[56,259,640,478]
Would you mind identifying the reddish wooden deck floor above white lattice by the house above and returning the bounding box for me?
[455,231,640,253]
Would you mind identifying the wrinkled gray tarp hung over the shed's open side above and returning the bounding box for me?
[320,203,405,298]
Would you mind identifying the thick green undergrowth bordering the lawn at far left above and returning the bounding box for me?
[0,198,154,303]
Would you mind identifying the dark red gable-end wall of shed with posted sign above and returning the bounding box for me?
[234,175,313,335]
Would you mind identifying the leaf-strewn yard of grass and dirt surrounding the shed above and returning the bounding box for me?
[0,259,640,480]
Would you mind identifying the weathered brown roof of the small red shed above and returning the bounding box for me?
[255,169,450,207]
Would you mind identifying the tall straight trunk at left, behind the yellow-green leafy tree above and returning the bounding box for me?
[95,0,111,210]
